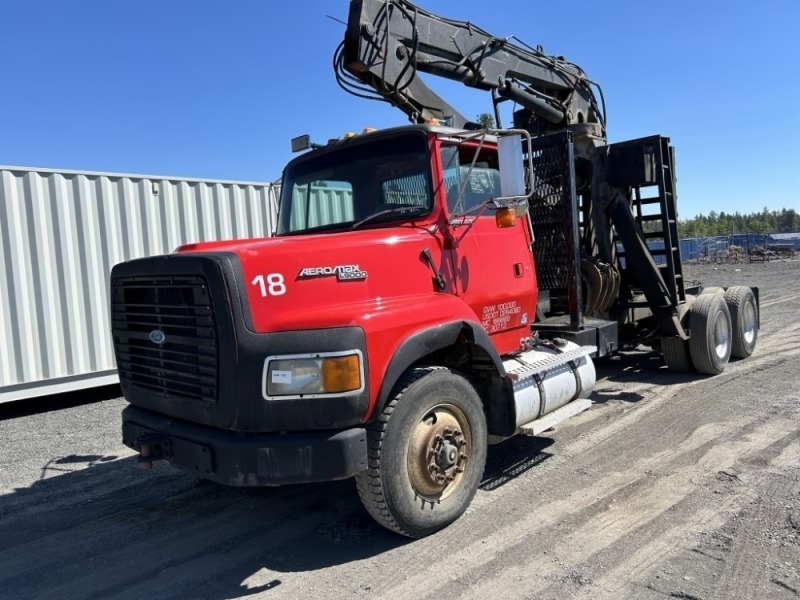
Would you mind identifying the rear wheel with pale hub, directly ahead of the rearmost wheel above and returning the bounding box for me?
[689,293,731,375]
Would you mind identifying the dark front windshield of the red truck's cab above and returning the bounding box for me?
[277,133,432,235]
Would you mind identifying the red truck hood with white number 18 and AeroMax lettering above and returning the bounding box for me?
[178,226,454,332]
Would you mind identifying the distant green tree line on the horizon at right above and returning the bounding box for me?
[678,207,800,238]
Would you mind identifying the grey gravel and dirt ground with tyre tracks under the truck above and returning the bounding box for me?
[0,261,800,600]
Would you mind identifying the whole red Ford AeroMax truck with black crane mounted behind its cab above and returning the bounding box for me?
[111,0,758,537]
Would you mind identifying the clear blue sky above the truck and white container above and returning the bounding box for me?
[0,0,800,218]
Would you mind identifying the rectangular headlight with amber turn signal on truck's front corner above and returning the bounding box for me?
[263,350,364,400]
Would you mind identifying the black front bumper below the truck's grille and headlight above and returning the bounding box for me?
[122,406,367,487]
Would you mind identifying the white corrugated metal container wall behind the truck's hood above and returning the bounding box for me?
[0,167,276,402]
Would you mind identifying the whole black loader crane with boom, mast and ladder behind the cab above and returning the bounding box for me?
[334,0,688,360]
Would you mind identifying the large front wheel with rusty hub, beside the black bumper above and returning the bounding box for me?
[356,367,487,538]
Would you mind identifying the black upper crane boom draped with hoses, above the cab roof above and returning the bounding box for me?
[335,0,605,138]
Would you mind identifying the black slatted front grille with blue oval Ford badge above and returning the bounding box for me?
[111,276,218,404]
